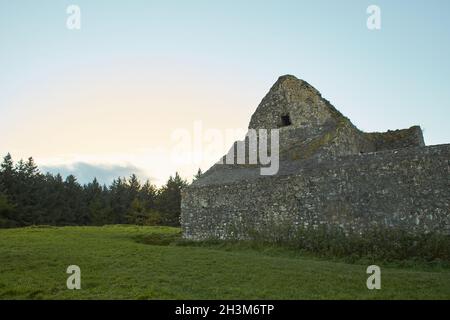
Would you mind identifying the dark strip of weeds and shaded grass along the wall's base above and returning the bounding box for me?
[133,231,450,271]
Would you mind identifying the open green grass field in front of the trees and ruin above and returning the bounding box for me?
[0,226,450,299]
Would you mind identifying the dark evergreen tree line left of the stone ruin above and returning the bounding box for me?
[0,154,201,228]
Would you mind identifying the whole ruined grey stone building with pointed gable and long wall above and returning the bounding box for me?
[181,75,450,239]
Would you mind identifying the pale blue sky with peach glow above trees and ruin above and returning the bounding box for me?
[0,0,450,185]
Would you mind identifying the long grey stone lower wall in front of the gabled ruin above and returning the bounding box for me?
[181,145,450,239]
